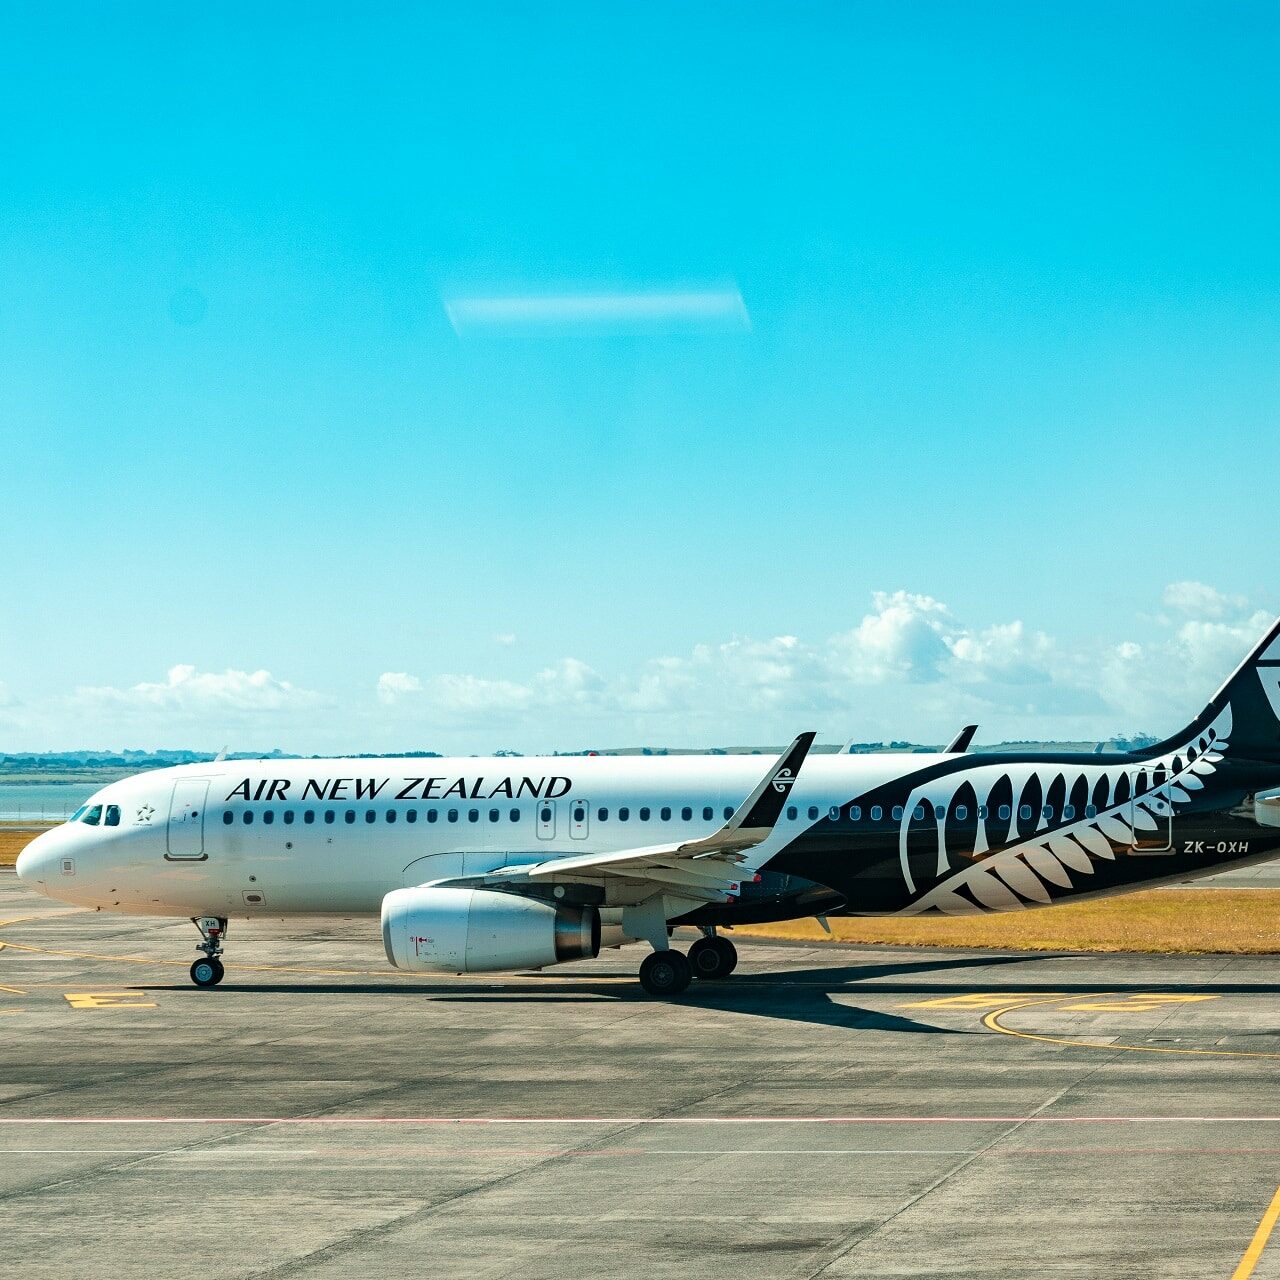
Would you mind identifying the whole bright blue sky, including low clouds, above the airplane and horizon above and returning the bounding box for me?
[0,3,1280,750]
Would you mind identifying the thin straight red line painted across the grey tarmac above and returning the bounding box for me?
[0,1115,1280,1126]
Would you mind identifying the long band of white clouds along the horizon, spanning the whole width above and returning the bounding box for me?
[0,584,1271,753]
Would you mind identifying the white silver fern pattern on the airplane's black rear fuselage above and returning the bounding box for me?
[899,704,1231,915]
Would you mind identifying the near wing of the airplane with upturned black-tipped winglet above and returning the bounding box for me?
[484,733,817,902]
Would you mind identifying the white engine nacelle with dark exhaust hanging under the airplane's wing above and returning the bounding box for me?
[383,886,600,973]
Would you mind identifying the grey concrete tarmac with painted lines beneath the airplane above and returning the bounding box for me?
[0,873,1280,1280]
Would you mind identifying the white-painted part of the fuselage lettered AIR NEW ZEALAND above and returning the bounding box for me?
[12,755,931,918]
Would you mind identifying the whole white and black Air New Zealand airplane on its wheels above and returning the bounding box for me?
[17,620,1280,997]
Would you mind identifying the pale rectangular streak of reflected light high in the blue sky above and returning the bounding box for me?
[444,284,751,337]
